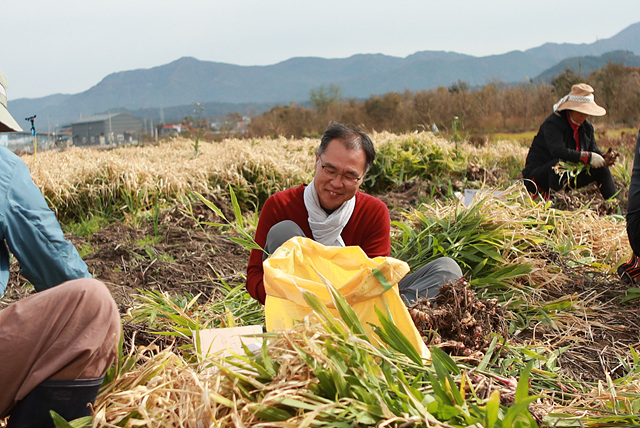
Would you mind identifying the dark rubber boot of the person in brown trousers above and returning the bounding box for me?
[7,377,104,428]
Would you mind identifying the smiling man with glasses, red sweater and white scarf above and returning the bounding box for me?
[246,122,462,305]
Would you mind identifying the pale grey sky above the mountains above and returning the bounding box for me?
[0,0,640,99]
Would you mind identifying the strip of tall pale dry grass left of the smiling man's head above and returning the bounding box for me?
[24,139,314,214]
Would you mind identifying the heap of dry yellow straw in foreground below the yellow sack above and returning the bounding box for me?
[93,324,376,427]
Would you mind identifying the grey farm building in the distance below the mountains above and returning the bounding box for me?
[71,113,143,146]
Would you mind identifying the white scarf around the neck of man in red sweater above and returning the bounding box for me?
[304,180,356,247]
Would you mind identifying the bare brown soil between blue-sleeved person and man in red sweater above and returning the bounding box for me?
[0,199,249,349]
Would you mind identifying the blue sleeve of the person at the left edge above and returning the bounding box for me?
[0,155,91,291]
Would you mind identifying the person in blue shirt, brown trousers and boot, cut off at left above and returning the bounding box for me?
[0,71,121,428]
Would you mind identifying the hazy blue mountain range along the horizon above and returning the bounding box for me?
[9,22,640,127]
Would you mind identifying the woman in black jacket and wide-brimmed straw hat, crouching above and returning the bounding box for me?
[522,83,616,199]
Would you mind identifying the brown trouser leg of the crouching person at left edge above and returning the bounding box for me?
[0,278,121,416]
